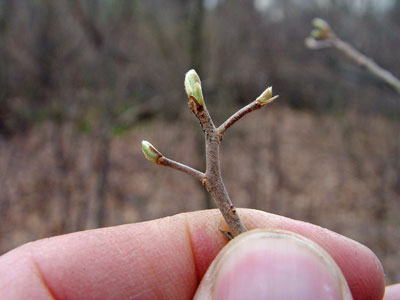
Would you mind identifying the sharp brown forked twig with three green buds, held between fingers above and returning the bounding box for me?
[142,70,278,237]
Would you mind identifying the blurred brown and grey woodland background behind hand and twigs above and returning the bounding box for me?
[0,0,400,283]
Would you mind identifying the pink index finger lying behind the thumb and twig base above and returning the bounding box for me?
[0,209,385,299]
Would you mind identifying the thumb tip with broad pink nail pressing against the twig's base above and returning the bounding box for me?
[194,229,353,300]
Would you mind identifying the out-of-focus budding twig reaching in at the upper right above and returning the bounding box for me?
[306,18,400,94]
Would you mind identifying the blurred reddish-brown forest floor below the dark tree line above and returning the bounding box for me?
[0,106,400,283]
